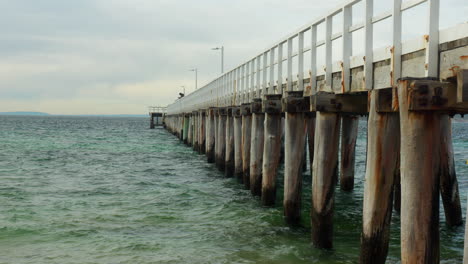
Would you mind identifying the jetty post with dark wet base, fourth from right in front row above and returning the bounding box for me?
[282,91,309,225]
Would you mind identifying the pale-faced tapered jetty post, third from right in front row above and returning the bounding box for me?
[311,111,340,248]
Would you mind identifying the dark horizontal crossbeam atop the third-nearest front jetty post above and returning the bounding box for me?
[310,92,368,115]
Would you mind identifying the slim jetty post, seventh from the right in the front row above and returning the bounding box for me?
[241,104,252,190]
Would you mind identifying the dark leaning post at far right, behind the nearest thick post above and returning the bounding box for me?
[439,115,463,226]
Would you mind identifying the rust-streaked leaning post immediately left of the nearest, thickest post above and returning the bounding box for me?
[360,90,400,264]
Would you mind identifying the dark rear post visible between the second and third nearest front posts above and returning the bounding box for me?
[340,115,359,191]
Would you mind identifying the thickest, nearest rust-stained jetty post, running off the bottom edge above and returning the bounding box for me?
[398,78,445,264]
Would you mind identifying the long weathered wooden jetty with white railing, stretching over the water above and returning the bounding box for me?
[165,0,468,264]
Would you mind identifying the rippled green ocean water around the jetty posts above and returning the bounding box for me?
[0,116,468,264]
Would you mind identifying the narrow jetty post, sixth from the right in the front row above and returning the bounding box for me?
[250,98,265,196]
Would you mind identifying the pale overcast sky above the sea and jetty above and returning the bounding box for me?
[0,0,468,114]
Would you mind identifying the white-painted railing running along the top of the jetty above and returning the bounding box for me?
[167,0,468,114]
